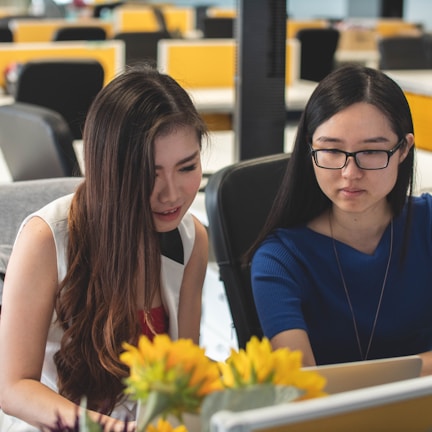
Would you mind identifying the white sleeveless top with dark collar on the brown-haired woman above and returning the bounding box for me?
[0,194,195,432]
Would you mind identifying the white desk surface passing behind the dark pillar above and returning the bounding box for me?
[188,80,318,113]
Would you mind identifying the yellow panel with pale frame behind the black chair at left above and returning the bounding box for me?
[0,41,124,86]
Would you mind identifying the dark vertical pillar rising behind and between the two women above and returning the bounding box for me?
[234,0,287,160]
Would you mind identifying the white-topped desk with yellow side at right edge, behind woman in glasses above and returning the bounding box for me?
[386,69,432,151]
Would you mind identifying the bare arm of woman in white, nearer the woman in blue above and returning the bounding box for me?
[179,217,208,344]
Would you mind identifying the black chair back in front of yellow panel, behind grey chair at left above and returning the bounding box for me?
[15,59,104,139]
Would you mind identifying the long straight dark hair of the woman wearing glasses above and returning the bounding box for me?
[247,65,414,259]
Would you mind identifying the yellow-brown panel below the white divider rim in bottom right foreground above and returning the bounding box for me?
[254,396,432,432]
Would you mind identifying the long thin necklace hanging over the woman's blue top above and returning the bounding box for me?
[329,213,393,360]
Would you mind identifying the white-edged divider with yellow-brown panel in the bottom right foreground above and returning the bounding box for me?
[210,376,432,432]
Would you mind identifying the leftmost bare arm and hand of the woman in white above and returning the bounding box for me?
[0,217,132,431]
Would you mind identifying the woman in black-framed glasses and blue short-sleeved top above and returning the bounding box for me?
[251,66,432,374]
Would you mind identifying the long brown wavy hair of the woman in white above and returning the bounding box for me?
[54,65,206,413]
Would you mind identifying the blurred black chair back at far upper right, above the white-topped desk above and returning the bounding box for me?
[377,36,431,70]
